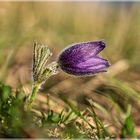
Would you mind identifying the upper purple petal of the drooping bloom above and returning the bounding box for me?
[59,41,105,63]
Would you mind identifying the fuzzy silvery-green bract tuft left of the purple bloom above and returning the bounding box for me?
[33,42,58,84]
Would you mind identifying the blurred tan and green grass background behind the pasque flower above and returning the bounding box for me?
[0,2,140,138]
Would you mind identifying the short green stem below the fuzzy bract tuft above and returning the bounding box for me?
[27,84,39,110]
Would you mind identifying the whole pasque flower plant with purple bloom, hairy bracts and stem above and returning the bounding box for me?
[26,41,110,109]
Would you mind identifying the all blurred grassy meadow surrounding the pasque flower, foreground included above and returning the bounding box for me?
[0,2,140,139]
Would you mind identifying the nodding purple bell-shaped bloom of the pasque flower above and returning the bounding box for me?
[58,41,110,75]
